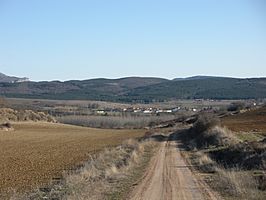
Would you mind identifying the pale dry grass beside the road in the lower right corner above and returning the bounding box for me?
[191,151,266,200]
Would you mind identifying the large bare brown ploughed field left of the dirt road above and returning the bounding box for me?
[0,122,145,197]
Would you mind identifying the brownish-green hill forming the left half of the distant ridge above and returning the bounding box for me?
[0,77,168,101]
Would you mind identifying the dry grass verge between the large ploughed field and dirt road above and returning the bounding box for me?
[66,140,152,200]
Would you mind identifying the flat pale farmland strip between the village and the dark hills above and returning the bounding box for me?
[3,98,235,116]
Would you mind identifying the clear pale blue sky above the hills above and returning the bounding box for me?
[0,0,266,80]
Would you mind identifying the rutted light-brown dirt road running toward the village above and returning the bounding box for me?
[130,137,217,200]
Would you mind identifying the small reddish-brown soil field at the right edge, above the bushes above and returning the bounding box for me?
[222,107,266,135]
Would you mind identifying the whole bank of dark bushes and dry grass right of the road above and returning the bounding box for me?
[180,113,266,200]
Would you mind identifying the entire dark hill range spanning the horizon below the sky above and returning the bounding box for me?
[0,72,266,102]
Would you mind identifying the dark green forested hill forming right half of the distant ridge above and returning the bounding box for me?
[127,77,266,101]
